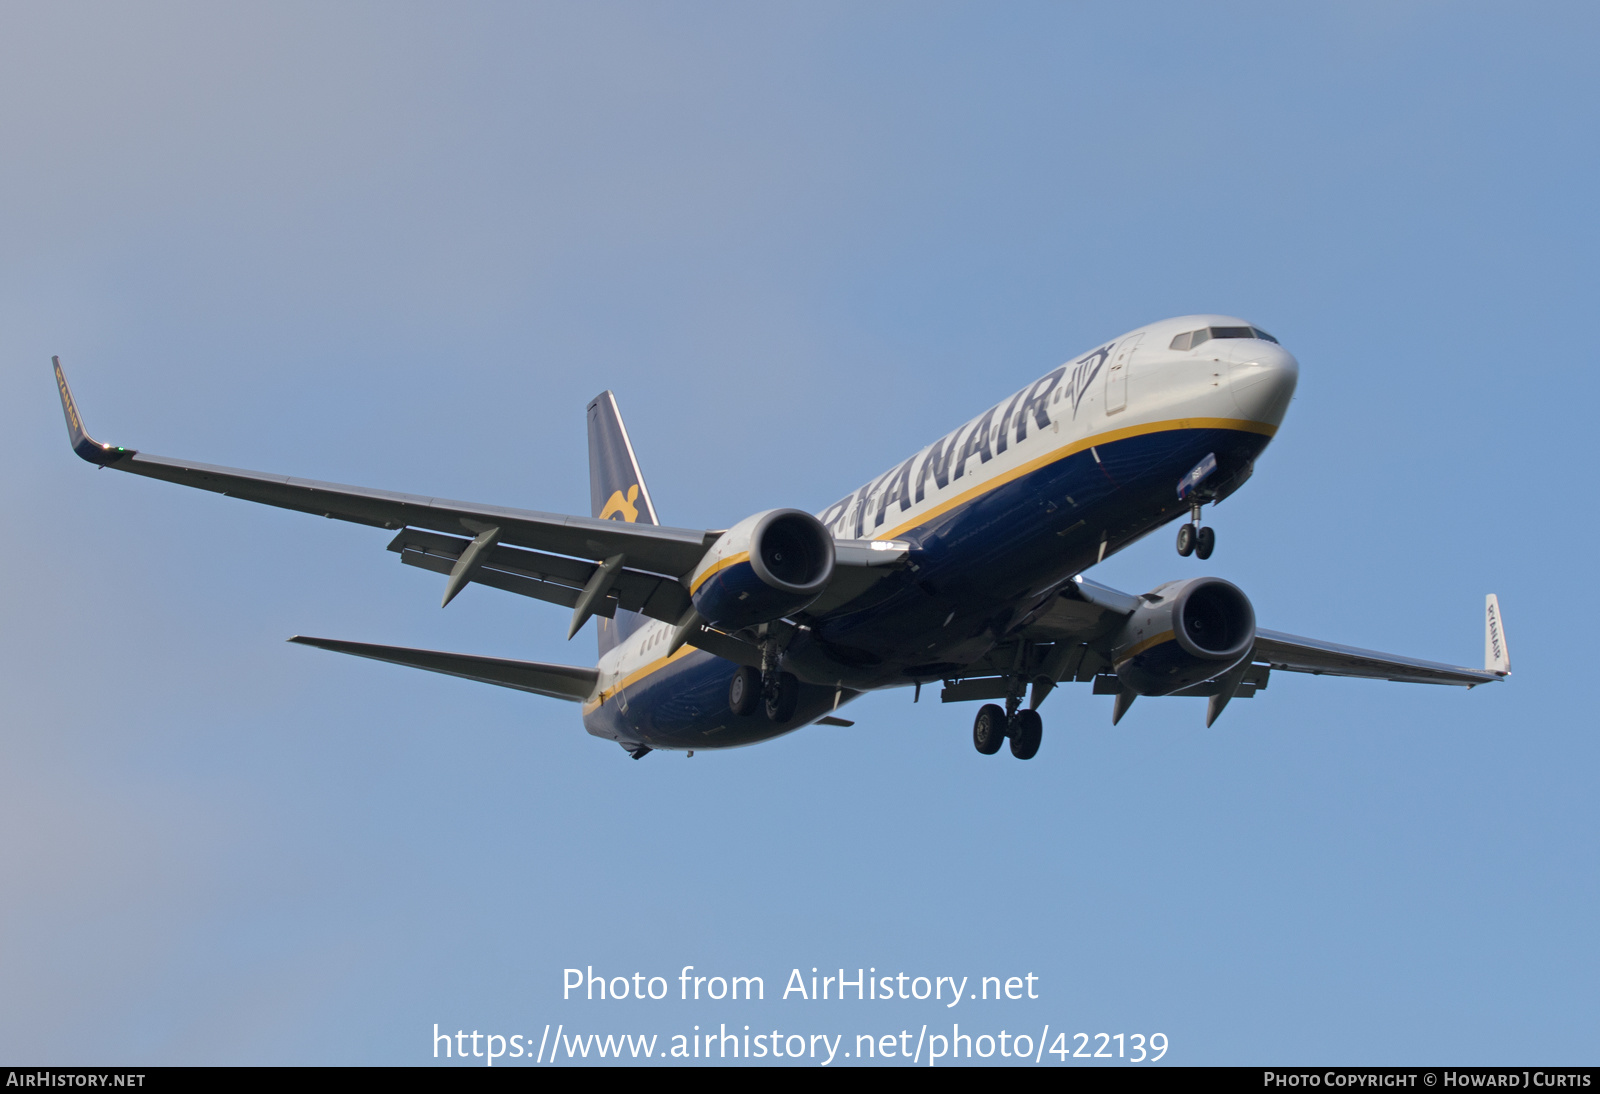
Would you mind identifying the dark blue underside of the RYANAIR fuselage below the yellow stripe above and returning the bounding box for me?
[584,429,1269,749]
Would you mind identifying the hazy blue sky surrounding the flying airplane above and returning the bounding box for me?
[0,3,1600,1064]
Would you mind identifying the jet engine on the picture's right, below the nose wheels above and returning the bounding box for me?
[1112,577,1256,696]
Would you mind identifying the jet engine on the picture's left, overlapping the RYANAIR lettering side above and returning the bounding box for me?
[690,509,834,630]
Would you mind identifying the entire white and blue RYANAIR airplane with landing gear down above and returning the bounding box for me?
[54,315,1510,760]
